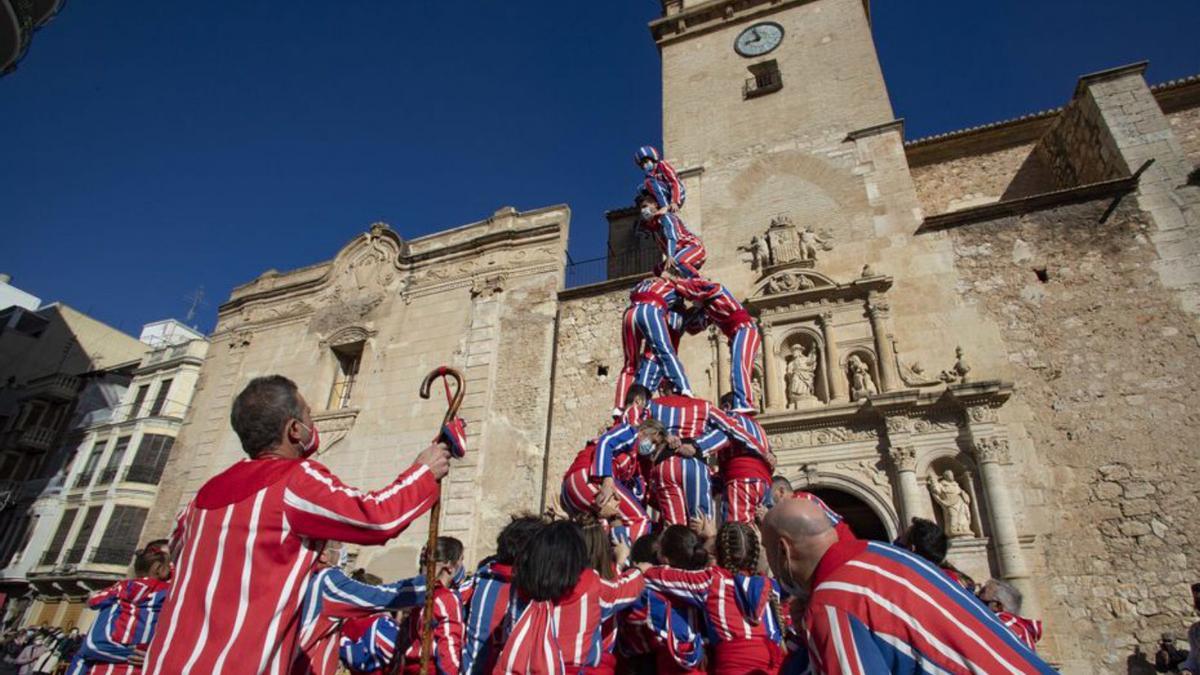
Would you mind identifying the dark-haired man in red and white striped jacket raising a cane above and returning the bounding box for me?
[145,375,450,675]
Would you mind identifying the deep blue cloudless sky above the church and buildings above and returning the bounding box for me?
[0,0,1200,334]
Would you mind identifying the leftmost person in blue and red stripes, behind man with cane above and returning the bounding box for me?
[67,539,170,675]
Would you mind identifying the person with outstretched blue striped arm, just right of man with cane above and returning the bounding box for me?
[290,546,425,675]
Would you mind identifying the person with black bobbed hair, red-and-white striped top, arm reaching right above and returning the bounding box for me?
[493,520,644,675]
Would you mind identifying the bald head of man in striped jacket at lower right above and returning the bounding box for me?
[762,498,838,586]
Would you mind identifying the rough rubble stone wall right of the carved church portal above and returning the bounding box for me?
[948,198,1200,673]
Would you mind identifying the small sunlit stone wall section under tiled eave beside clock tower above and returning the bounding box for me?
[912,143,1034,215]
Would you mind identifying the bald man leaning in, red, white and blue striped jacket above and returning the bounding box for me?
[763,500,1054,675]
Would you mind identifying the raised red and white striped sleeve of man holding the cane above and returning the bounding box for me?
[283,460,438,544]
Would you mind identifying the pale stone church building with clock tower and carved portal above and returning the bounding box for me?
[143,0,1200,673]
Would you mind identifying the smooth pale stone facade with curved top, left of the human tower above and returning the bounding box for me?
[143,208,569,578]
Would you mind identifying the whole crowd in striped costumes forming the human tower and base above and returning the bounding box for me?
[56,147,1051,675]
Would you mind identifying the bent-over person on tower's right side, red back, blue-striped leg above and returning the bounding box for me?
[674,279,762,414]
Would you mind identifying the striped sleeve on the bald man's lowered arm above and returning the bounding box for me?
[805,604,890,675]
